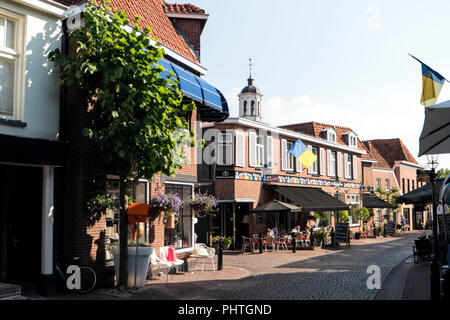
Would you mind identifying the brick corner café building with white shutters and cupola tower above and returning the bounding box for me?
[199,77,392,246]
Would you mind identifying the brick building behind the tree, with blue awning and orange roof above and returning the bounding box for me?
[15,0,228,294]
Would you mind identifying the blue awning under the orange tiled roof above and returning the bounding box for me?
[159,59,229,114]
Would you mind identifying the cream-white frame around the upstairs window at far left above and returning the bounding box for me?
[0,8,25,121]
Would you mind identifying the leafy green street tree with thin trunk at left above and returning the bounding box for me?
[49,0,195,286]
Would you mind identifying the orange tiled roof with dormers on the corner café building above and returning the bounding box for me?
[280,121,376,160]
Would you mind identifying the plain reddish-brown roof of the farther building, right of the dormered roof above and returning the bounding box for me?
[364,138,419,168]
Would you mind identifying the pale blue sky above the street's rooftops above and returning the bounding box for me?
[174,0,450,168]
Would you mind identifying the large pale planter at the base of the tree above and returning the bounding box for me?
[111,246,153,288]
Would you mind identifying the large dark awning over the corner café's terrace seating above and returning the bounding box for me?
[269,184,349,212]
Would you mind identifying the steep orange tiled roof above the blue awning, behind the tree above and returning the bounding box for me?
[54,0,199,63]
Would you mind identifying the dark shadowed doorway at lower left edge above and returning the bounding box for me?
[0,165,43,283]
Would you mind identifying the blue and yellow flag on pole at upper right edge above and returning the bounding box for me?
[410,55,446,107]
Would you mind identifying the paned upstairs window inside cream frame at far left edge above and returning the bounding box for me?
[0,12,19,116]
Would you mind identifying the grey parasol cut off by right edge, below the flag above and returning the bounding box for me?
[419,100,450,157]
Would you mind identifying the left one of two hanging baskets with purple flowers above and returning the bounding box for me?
[150,193,184,229]
